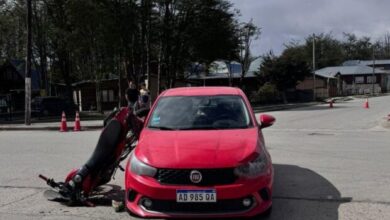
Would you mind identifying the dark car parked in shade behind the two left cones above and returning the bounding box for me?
[31,96,77,117]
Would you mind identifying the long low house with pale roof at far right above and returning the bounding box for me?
[304,65,389,97]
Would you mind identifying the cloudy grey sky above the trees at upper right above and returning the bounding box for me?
[230,0,390,55]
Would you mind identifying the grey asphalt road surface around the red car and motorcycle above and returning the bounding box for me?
[0,96,390,220]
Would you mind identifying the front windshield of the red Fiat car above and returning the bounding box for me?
[148,95,251,130]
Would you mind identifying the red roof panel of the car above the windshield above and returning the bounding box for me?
[161,86,242,97]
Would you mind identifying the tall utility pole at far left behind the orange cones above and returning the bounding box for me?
[24,0,32,125]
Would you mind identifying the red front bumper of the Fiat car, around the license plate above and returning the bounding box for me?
[125,166,273,218]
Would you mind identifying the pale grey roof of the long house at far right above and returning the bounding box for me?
[315,65,387,78]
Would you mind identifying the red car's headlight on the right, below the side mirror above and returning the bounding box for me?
[234,151,268,178]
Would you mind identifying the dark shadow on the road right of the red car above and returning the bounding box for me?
[267,164,352,220]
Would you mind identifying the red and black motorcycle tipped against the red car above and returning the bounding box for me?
[39,107,149,206]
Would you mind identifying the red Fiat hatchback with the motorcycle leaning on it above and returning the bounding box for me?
[125,87,275,218]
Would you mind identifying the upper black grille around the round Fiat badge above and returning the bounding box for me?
[155,168,237,186]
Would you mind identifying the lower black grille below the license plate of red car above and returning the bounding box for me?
[142,198,255,214]
